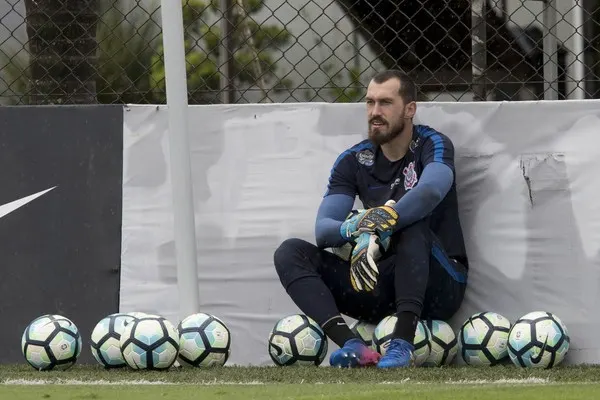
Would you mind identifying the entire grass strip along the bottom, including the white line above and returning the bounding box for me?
[0,365,600,400]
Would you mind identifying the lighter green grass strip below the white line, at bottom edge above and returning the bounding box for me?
[0,383,600,400]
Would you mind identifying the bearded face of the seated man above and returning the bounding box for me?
[366,79,406,146]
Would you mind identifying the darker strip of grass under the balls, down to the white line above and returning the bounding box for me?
[0,365,600,384]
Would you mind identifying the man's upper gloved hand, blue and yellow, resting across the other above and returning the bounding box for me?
[340,200,398,241]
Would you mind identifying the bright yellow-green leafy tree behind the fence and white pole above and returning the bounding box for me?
[151,0,291,104]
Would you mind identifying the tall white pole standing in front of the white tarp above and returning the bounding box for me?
[161,0,199,319]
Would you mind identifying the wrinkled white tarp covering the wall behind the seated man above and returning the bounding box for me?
[120,101,600,365]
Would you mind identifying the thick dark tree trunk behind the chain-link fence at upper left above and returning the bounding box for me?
[25,0,98,104]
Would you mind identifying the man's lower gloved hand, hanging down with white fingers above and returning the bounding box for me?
[350,232,390,292]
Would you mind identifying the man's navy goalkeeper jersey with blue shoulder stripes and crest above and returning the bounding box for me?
[325,125,466,263]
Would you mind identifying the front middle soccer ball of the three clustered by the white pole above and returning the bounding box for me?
[119,316,179,370]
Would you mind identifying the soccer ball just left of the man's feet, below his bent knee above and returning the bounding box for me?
[269,314,328,366]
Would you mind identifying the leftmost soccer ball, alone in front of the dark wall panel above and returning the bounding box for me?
[21,314,81,371]
